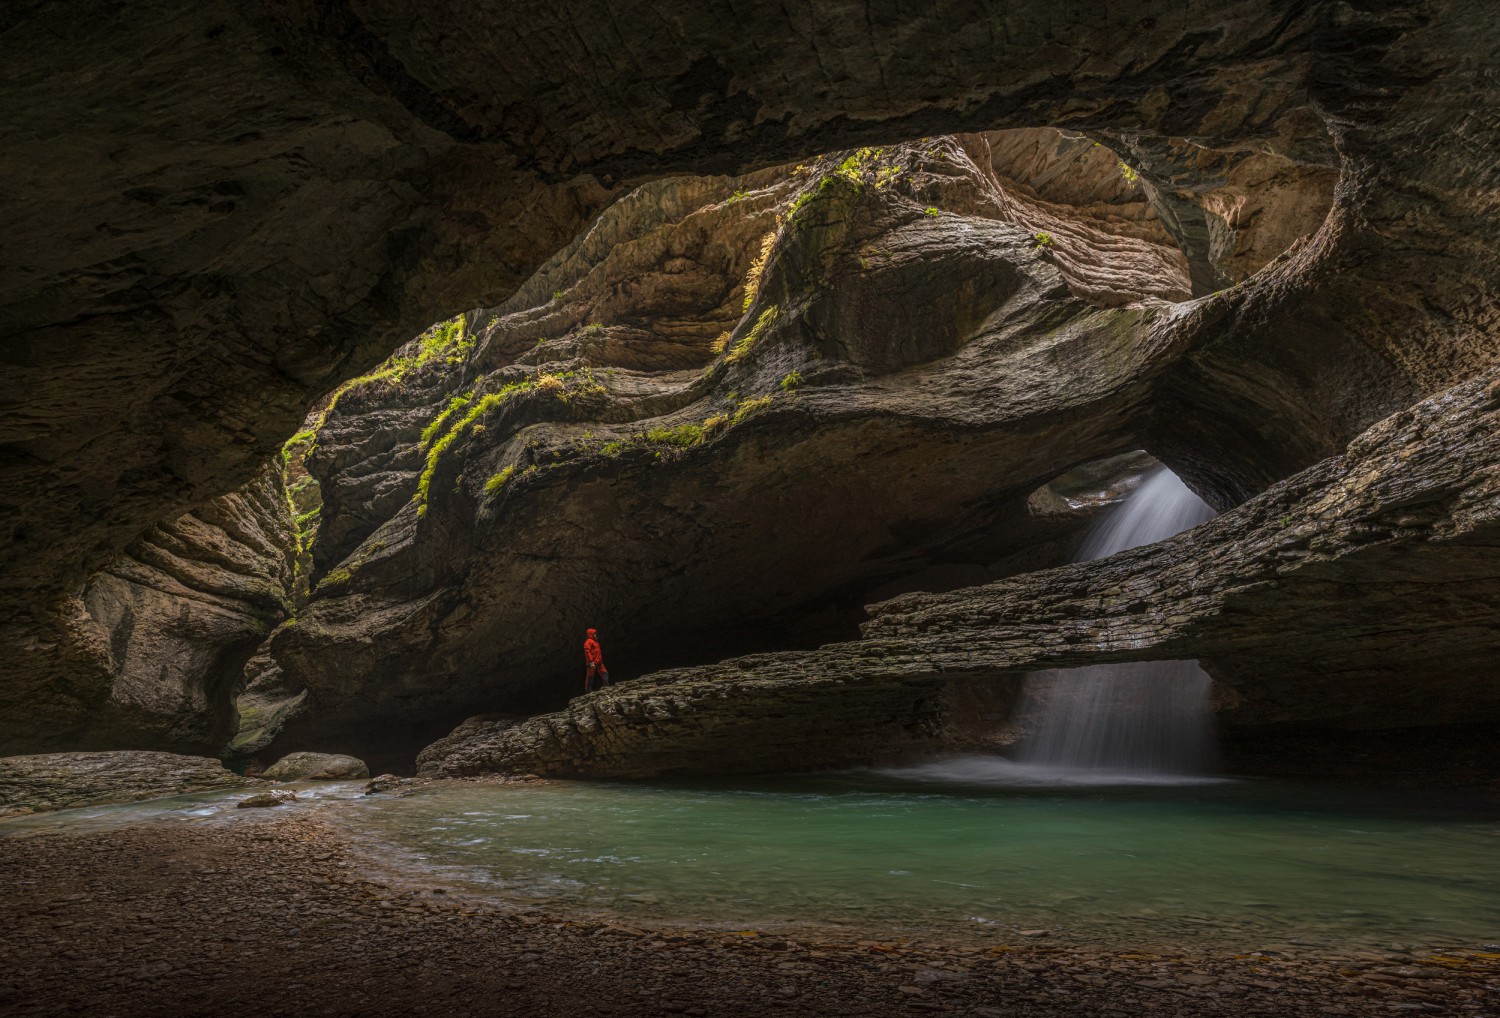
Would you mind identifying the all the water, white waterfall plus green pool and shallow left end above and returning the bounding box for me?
[0,469,1500,954]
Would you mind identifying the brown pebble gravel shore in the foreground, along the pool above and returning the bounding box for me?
[0,811,1500,1018]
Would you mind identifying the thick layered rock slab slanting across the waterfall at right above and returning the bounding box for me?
[864,365,1500,729]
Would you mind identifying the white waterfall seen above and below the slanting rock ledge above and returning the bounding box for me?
[1017,466,1214,774]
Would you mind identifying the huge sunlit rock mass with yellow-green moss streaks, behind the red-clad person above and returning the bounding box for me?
[270,136,1248,753]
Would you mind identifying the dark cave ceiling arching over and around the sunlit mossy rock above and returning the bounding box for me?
[0,0,1500,761]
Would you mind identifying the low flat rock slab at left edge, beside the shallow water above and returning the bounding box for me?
[0,751,260,817]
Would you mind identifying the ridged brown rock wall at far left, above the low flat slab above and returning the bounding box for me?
[0,469,296,754]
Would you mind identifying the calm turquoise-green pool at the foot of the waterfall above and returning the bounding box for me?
[348,768,1500,949]
